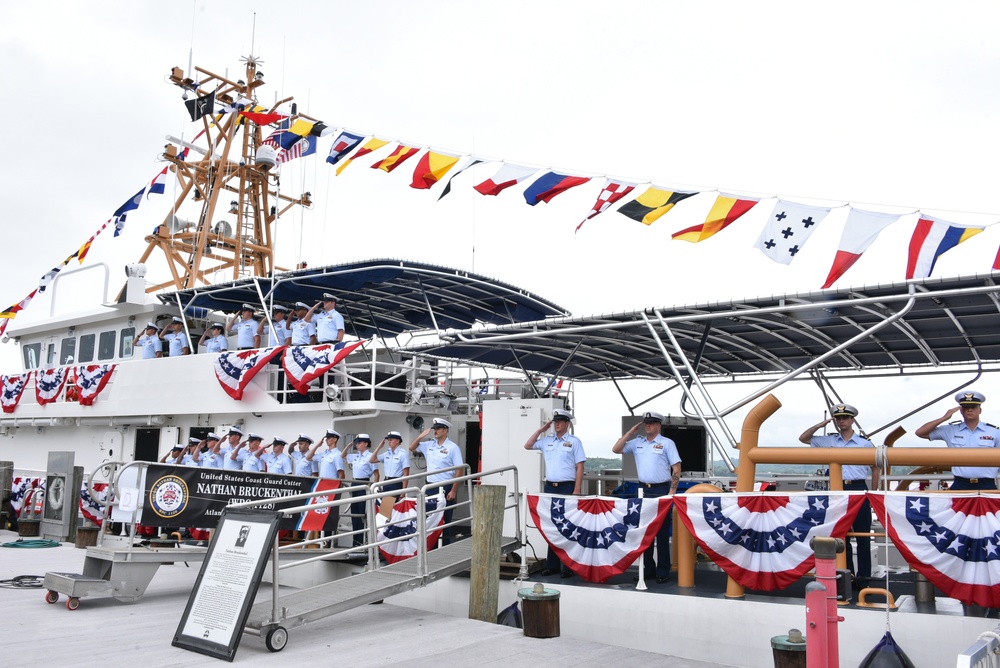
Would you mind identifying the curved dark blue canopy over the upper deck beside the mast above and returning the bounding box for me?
[160,259,568,338]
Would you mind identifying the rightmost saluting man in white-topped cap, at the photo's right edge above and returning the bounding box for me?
[915,392,1000,491]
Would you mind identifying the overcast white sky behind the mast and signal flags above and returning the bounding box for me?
[0,0,1000,451]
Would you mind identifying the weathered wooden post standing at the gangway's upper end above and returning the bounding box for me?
[469,485,507,624]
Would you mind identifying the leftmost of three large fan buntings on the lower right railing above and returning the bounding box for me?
[528,494,670,582]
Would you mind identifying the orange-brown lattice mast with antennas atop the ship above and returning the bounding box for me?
[139,56,315,292]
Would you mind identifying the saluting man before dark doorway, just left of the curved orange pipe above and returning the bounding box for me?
[611,411,681,584]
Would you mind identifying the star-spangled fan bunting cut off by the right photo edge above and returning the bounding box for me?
[868,492,1000,608]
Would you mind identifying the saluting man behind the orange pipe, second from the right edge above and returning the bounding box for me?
[799,404,878,587]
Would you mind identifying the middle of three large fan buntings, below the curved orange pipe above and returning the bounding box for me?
[674,492,865,591]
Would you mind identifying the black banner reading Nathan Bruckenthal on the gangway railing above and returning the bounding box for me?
[139,464,340,531]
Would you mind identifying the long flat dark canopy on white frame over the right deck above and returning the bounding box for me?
[407,274,1000,381]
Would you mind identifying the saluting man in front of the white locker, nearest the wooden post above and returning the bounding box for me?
[524,408,587,578]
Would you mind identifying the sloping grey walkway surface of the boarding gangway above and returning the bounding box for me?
[246,536,518,631]
